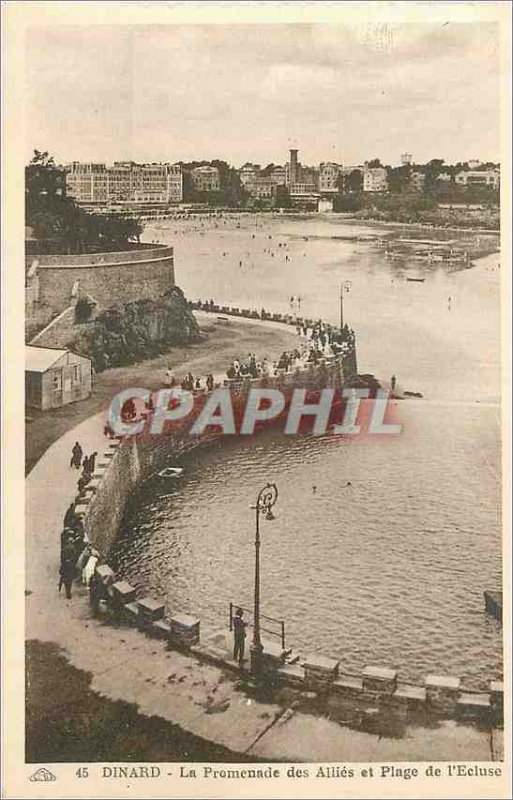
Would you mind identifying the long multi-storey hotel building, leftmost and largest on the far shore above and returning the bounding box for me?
[66,161,183,205]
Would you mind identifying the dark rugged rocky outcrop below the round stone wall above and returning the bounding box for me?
[68,286,200,372]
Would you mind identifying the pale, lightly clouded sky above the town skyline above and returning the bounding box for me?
[25,22,500,166]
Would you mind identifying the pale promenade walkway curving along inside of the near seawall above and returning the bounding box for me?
[25,323,502,762]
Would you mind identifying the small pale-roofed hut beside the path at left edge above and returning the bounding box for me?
[25,346,91,411]
